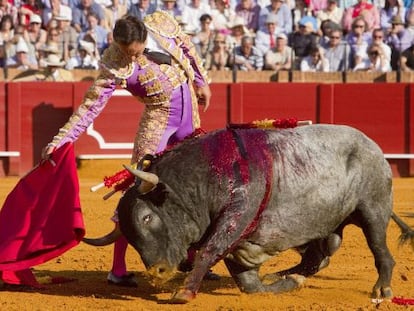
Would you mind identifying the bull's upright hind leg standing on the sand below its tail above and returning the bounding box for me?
[359,211,395,299]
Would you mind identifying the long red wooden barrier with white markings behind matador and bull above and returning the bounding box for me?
[0,82,414,176]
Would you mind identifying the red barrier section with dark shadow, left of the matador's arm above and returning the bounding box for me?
[7,82,74,175]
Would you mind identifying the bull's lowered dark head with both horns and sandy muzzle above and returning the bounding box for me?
[84,167,194,284]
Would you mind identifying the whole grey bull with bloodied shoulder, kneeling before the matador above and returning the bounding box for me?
[85,124,414,303]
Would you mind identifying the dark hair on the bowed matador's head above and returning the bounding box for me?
[113,15,147,45]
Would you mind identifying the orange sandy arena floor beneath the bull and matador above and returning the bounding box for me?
[0,161,414,311]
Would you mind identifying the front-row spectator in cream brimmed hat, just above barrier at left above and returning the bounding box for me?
[36,54,74,82]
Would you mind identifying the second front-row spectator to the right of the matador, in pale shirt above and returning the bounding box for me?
[229,36,263,71]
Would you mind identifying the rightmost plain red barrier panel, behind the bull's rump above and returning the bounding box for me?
[321,83,410,175]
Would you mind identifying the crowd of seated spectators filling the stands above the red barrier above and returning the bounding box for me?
[0,0,414,76]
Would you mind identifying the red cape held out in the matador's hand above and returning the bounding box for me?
[0,144,85,271]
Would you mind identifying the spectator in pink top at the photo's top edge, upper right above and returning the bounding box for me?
[343,0,380,32]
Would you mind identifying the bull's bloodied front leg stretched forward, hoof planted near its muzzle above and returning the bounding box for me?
[171,186,257,303]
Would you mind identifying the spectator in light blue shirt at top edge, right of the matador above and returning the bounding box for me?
[259,0,293,34]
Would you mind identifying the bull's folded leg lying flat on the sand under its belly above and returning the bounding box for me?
[224,258,305,293]
